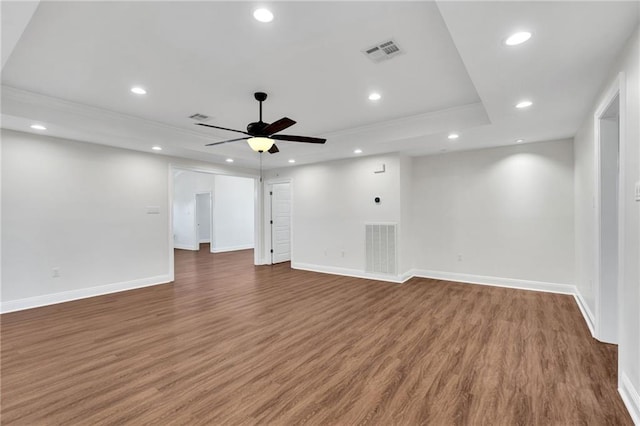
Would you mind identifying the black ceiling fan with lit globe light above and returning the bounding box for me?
[196,92,327,154]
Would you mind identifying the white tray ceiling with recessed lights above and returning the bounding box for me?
[2,1,639,168]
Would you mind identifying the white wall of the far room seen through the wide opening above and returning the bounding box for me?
[173,170,255,252]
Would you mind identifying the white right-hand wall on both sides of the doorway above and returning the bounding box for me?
[574,30,640,423]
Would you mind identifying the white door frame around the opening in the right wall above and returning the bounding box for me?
[593,73,626,344]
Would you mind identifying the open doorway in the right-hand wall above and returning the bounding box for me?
[595,85,621,344]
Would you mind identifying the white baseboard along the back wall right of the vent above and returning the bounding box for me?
[409,269,576,295]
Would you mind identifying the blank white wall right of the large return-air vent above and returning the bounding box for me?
[411,140,574,291]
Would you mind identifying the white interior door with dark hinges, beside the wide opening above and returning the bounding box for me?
[269,183,291,263]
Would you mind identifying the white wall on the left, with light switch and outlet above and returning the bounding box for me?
[2,130,173,310]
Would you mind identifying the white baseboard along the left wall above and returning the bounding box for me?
[0,275,172,314]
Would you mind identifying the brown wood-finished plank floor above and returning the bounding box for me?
[0,250,632,425]
